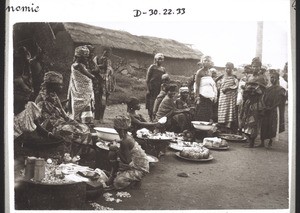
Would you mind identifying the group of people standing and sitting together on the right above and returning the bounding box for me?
[146,53,287,148]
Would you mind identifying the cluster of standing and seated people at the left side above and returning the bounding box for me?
[14,45,113,155]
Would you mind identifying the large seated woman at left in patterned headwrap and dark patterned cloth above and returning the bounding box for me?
[35,71,91,154]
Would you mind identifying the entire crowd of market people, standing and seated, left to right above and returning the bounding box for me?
[14,45,286,189]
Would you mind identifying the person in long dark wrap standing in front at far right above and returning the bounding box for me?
[258,70,286,147]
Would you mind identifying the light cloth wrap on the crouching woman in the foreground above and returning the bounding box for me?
[114,138,149,189]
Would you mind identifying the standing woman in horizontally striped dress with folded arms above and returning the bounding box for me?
[218,62,239,130]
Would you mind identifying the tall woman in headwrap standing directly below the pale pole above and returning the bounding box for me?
[240,58,267,148]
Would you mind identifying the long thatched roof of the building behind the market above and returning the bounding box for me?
[63,23,203,59]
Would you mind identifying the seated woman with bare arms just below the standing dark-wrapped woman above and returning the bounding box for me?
[156,84,190,133]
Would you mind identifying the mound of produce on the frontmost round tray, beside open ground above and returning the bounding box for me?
[180,146,210,159]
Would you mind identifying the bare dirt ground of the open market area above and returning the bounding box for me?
[15,105,289,210]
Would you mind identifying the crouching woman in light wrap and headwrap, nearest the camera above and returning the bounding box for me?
[106,116,149,189]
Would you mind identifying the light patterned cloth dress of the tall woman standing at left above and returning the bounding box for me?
[68,63,94,122]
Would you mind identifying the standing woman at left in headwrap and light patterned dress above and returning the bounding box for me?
[68,46,95,123]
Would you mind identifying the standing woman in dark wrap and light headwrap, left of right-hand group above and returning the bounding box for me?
[146,53,166,121]
